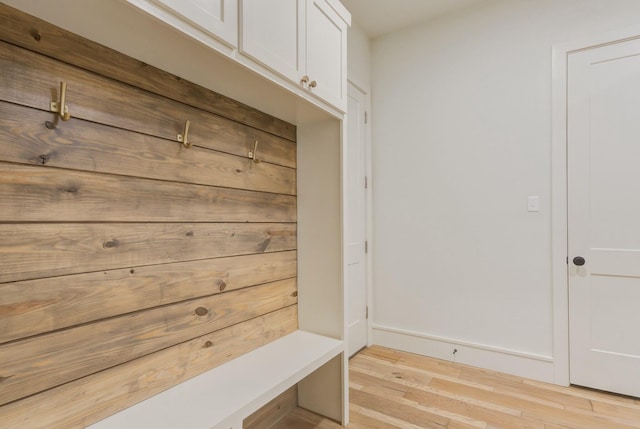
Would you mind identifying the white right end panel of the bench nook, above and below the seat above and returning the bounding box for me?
[296,120,349,424]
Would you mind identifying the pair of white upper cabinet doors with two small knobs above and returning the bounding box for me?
[239,0,350,111]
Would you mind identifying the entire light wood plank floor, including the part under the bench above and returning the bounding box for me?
[277,347,640,429]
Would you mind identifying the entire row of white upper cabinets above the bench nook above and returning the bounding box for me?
[127,0,351,113]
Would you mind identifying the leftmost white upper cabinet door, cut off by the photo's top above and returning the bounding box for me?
[145,0,238,47]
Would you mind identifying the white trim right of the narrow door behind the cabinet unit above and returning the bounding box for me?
[347,79,373,347]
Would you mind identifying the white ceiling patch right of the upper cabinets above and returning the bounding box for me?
[341,0,486,38]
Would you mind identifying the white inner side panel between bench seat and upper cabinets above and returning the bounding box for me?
[297,120,344,339]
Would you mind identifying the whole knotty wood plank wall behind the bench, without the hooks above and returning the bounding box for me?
[0,4,297,429]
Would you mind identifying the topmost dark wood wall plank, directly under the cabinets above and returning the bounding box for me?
[0,5,296,141]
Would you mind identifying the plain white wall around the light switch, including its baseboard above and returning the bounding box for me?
[372,0,640,381]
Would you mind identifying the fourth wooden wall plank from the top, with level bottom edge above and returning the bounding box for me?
[0,162,296,222]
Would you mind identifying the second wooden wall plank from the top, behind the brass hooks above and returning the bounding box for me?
[0,42,296,167]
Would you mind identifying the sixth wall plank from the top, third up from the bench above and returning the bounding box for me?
[0,251,297,343]
